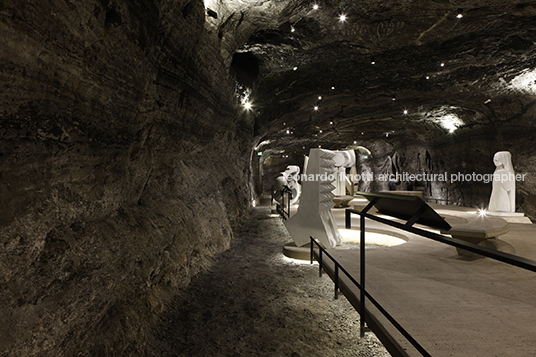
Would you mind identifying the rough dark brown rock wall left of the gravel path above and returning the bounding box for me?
[0,0,252,356]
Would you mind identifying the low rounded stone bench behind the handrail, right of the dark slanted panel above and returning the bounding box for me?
[441,217,510,258]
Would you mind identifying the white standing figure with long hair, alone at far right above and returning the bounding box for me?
[488,151,516,212]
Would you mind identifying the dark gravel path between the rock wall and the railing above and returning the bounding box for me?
[153,207,390,357]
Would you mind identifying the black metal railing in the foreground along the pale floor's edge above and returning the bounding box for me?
[310,200,536,356]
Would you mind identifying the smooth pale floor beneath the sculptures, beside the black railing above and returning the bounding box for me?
[322,202,536,357]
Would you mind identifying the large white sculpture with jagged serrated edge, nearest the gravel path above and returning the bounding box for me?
[285,149,349,248]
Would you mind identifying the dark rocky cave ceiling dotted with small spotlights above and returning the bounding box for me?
[214,0,536,154]
